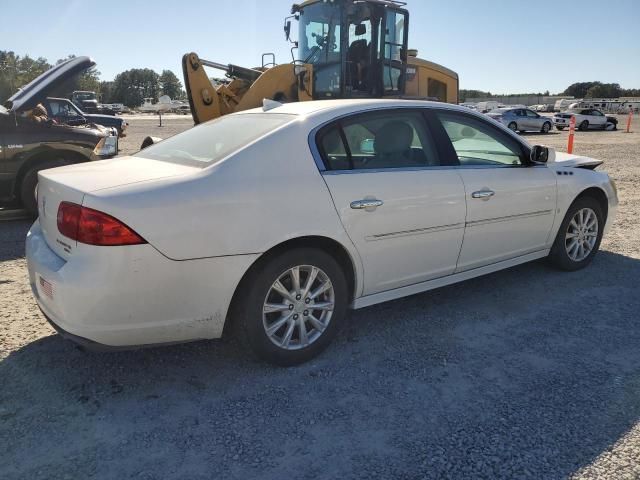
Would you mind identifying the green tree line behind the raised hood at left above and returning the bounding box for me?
[0,50,186,108]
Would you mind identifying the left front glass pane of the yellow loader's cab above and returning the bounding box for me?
[298,3,342,97]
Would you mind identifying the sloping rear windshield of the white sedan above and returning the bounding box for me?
[135,113,296,168]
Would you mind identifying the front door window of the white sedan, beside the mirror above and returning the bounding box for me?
[437,112,523,167]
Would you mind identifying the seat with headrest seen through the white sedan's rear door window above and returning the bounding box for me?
[367,120,428,168]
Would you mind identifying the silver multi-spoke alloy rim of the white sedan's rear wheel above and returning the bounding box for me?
[262,265,335,350]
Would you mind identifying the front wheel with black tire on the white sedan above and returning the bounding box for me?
[549,197,606,272]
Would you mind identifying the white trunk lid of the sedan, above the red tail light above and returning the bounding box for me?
[38,157,196,260]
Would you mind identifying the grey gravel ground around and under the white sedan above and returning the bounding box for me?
[0,113,640,480]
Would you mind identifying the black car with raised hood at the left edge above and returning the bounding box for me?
[0,57,118,215]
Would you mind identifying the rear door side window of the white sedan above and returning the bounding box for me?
[318,111,440,170]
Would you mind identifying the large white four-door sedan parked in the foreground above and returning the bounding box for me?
[27,100,618,365]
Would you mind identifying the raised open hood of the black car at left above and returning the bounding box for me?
[4,57,96,112]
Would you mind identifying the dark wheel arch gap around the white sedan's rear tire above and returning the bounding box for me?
[224,235,357,333]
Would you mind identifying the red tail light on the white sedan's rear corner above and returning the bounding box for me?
[58,202,147,247]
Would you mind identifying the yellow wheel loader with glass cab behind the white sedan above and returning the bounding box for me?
[182,0,458,124]
